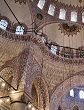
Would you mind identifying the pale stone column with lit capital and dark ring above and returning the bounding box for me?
[10,92,27,110]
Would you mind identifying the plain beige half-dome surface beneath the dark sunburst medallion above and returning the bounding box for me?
[43,23,84,48]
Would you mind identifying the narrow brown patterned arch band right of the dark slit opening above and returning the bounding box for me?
[32,76,49,110]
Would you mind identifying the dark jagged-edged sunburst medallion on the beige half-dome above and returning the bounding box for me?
[59,23,81,36]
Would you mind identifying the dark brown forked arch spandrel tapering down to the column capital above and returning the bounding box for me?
[0,48,29,90]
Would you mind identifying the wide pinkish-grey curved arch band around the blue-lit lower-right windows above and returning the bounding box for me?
[50,74,84,110]
